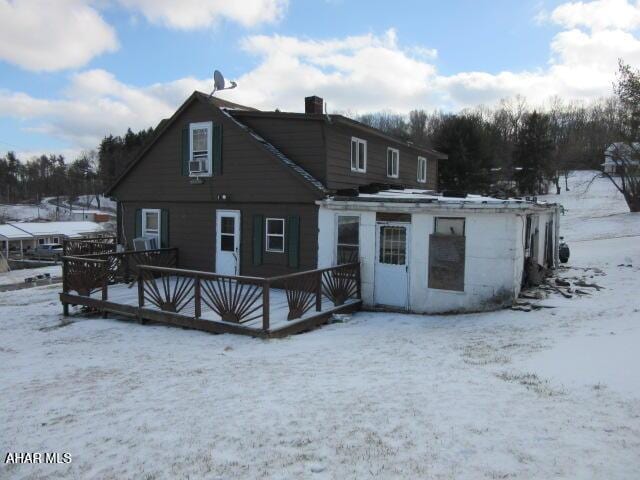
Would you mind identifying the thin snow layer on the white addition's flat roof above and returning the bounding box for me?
[329,189,549,208]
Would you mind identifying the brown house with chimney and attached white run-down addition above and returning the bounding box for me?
[107,92,559,312]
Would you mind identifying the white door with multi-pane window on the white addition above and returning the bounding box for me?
[374,223,410,308]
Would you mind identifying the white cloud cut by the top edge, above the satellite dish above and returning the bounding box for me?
[119,0,288,30]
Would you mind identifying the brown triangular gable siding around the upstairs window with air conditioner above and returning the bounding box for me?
[112,101,321,203]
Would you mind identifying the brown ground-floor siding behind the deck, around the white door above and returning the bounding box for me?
[121,201,318,277]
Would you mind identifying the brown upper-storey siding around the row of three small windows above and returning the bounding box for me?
[325,125,437,190]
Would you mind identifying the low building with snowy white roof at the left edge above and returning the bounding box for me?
[0,221,105,256]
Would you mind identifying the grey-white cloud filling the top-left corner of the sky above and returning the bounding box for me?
[0,0,118,71]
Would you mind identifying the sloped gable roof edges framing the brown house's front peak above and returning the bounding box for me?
[105,91,327,196]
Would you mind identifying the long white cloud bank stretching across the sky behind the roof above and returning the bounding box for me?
[0,2,640,154]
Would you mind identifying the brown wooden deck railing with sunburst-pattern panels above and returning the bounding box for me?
[62,248,361,332]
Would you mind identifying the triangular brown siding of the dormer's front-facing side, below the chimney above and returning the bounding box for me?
[231,115,326,183]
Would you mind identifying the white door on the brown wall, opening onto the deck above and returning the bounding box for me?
[216,210,240,275]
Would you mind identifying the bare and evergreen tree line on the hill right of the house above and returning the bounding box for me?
[357,60,640,211]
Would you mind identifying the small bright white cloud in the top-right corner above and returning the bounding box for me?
[548,0,640,31]
